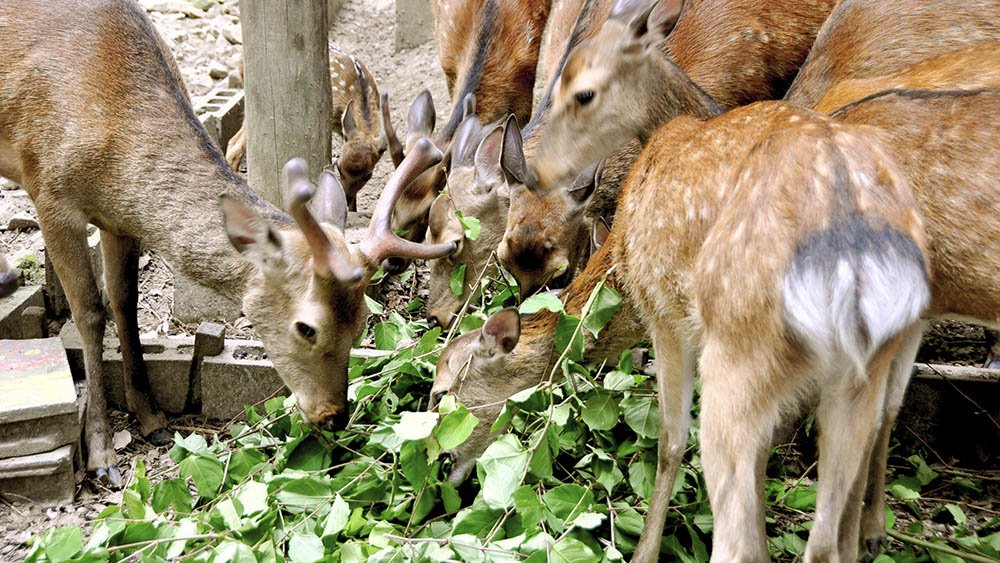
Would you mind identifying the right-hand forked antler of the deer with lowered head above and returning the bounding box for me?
[360,138,458,264]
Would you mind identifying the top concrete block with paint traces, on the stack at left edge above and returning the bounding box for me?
[0,338,80,458]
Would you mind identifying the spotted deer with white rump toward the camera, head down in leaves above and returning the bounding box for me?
[432,102,928,561]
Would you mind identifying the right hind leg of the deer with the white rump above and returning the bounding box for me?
[805,338,901,563]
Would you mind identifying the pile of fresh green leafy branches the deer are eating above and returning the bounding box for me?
[28,266,1000,563]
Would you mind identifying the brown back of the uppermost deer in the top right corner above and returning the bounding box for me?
[785,0,1000,107]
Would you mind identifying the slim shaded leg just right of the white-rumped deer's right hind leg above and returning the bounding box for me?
[859,325,924,563]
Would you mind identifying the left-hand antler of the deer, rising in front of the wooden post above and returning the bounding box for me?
[283,158,363,283]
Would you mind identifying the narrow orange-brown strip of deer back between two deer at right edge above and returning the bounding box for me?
[813,41,1000,113]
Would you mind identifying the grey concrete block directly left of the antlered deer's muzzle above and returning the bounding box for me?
[201,340,288,419]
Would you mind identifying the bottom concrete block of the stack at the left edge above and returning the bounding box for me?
[0,445,76,504]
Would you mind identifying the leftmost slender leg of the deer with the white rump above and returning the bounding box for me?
[632,325,695,562]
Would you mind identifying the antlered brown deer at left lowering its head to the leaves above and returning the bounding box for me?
[0,0,455,487]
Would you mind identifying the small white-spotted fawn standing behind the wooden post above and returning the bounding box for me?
[226,45,402,211]
